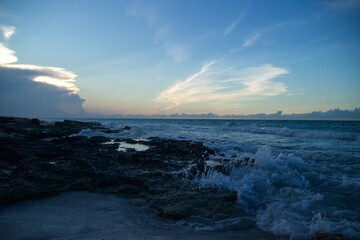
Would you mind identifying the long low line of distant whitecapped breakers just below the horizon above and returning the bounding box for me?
[74,121,360,142]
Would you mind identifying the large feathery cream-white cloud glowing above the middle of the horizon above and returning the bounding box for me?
[155,61,289,109]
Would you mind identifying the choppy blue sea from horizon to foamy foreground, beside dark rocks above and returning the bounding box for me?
[71,119,360,239]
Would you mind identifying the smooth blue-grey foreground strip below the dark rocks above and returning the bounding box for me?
[0,192,275,240]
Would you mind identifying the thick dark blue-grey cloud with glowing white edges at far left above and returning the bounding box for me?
[0,25,85,117]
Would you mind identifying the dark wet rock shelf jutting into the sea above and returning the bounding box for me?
[0,117,243,219]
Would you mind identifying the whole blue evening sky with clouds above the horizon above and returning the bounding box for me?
[0,0,360,117]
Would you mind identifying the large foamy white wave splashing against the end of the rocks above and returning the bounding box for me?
[184,147,360,239]
